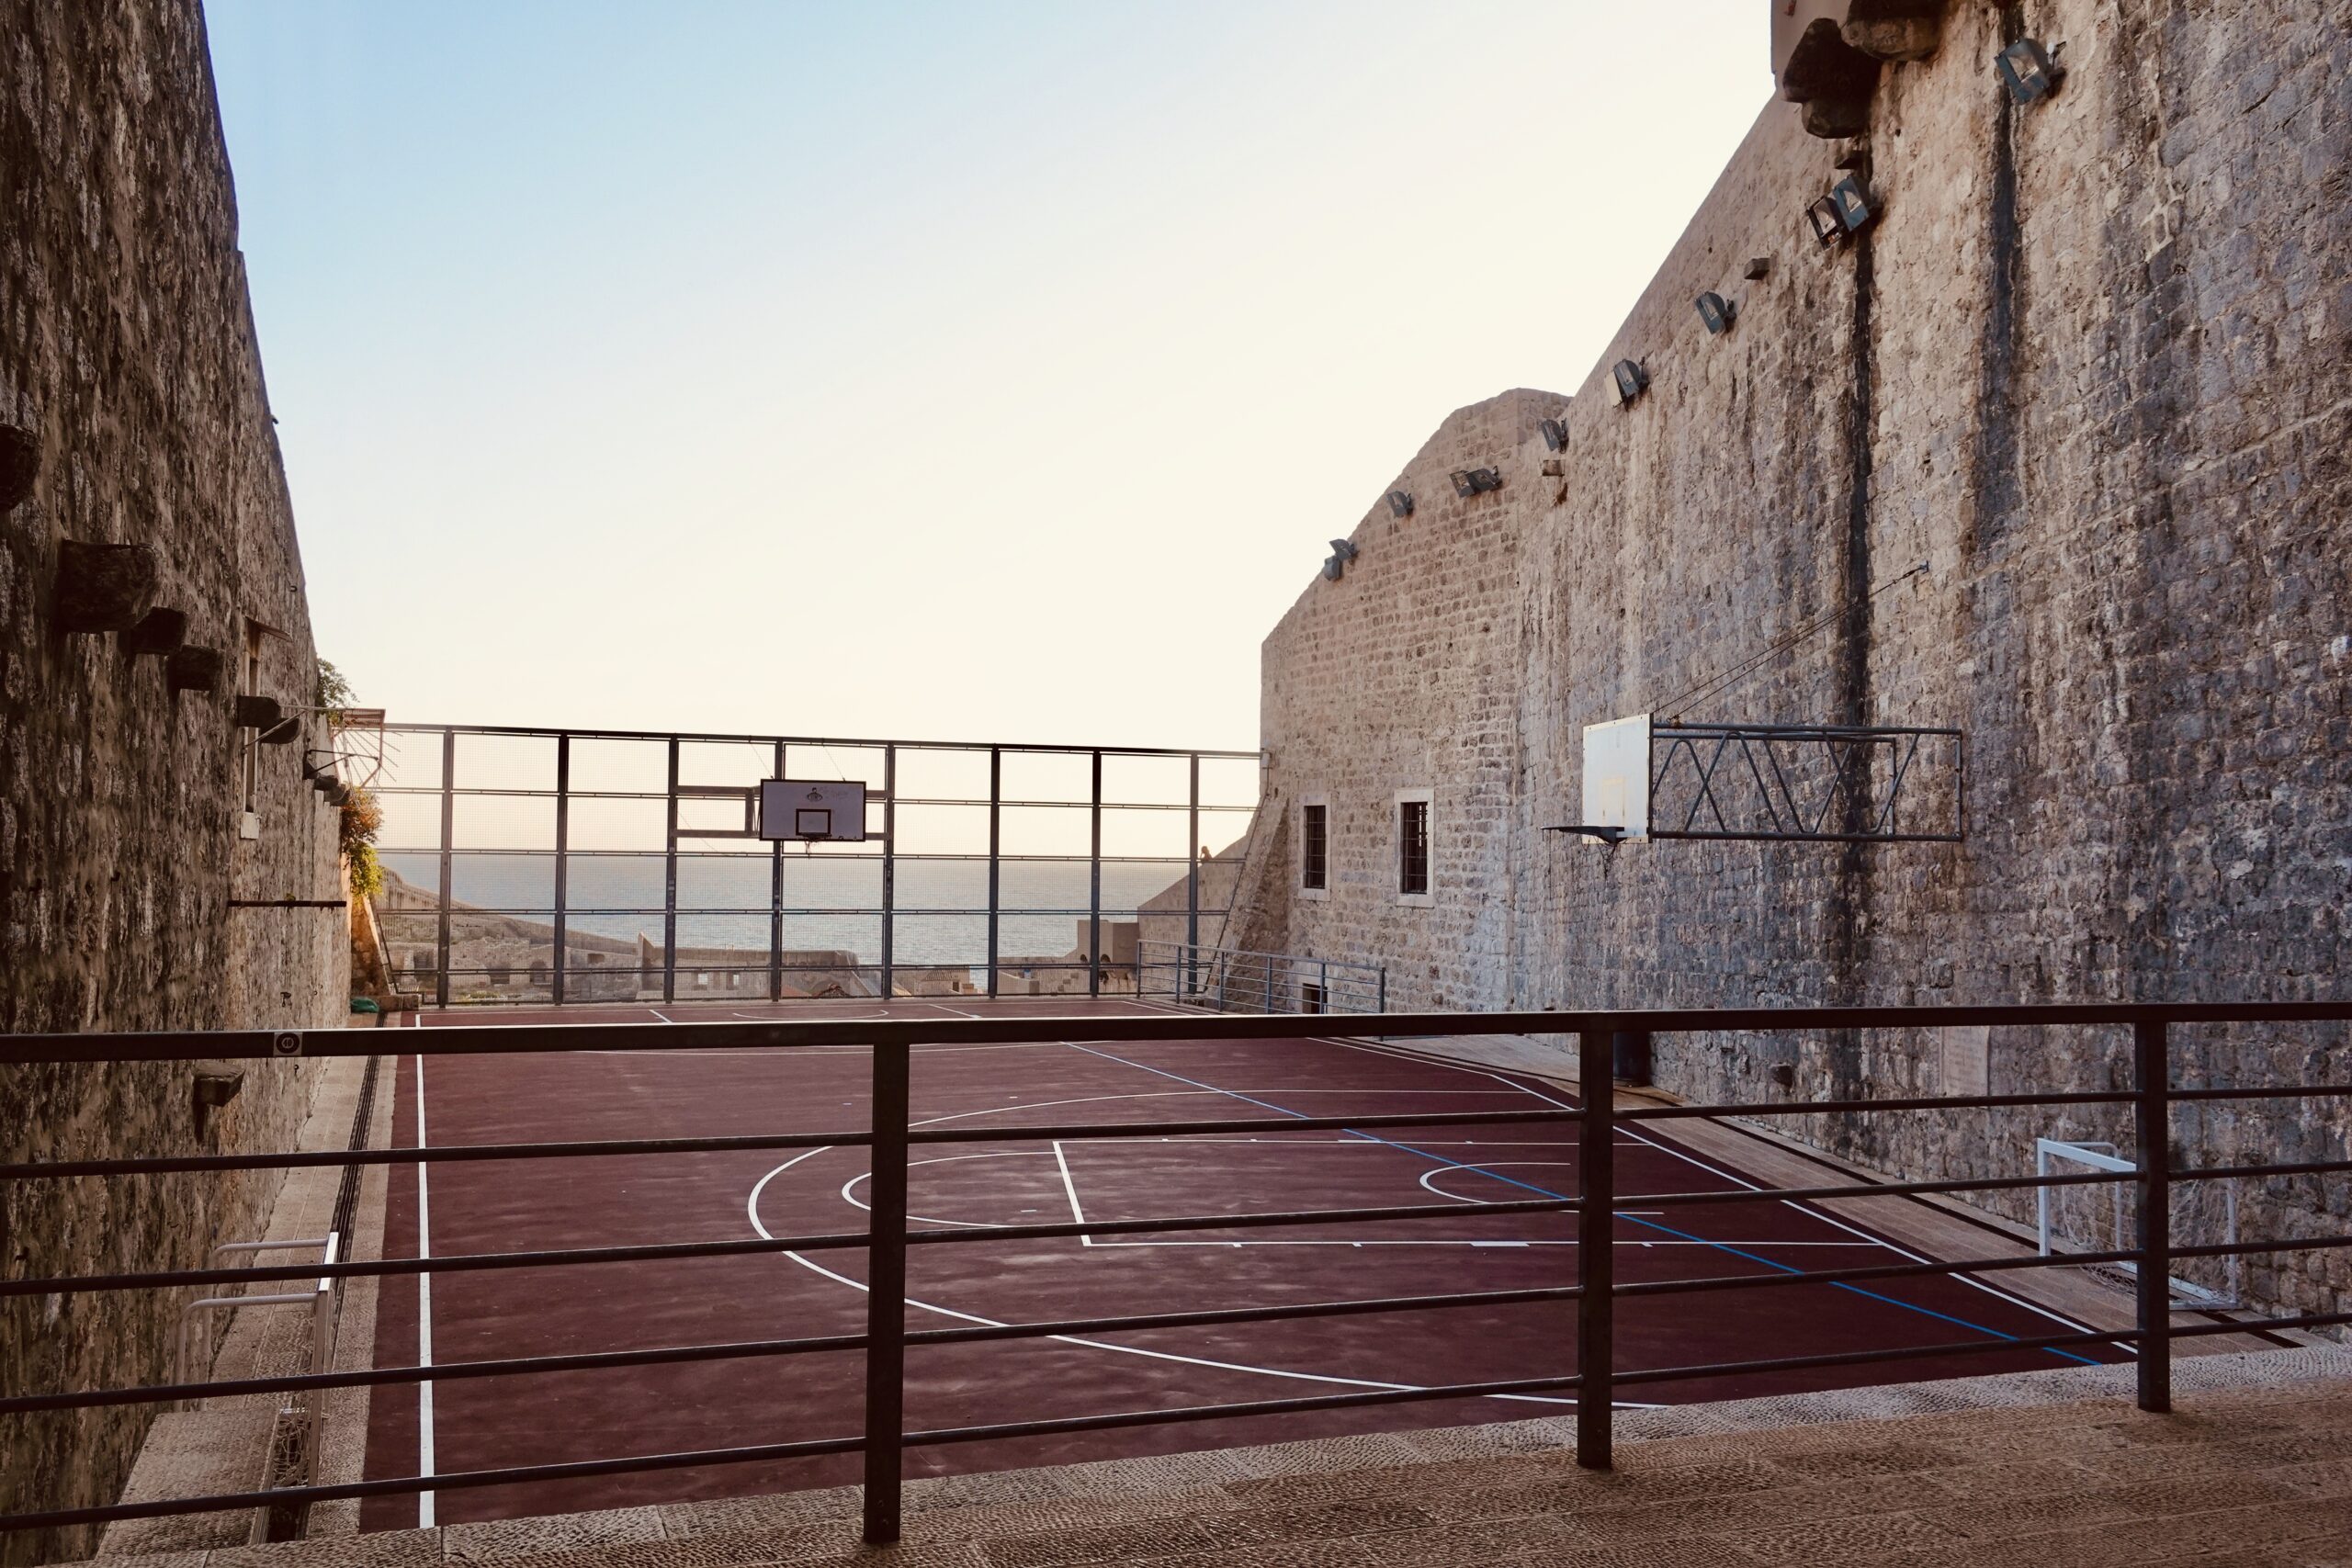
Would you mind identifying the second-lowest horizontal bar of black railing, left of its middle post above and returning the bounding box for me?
[0,1286,1583,1416]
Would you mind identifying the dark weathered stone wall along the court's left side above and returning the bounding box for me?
[0,0,348,1563]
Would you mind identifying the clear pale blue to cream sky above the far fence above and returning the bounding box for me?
[205,0,1771,748]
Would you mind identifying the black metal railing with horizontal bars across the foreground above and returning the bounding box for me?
[0,1004,2352,1542]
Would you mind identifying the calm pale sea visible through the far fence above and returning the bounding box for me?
[383,851,1223,964]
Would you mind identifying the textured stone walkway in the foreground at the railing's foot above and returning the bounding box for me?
[83,1347,2352,1568]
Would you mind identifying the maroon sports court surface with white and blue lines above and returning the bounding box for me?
[362,999,2109,1528]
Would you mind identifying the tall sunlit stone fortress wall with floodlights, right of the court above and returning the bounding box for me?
[1253,0,2352,1307]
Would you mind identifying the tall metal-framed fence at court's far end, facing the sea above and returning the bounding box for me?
[374,724,1265,1009]
